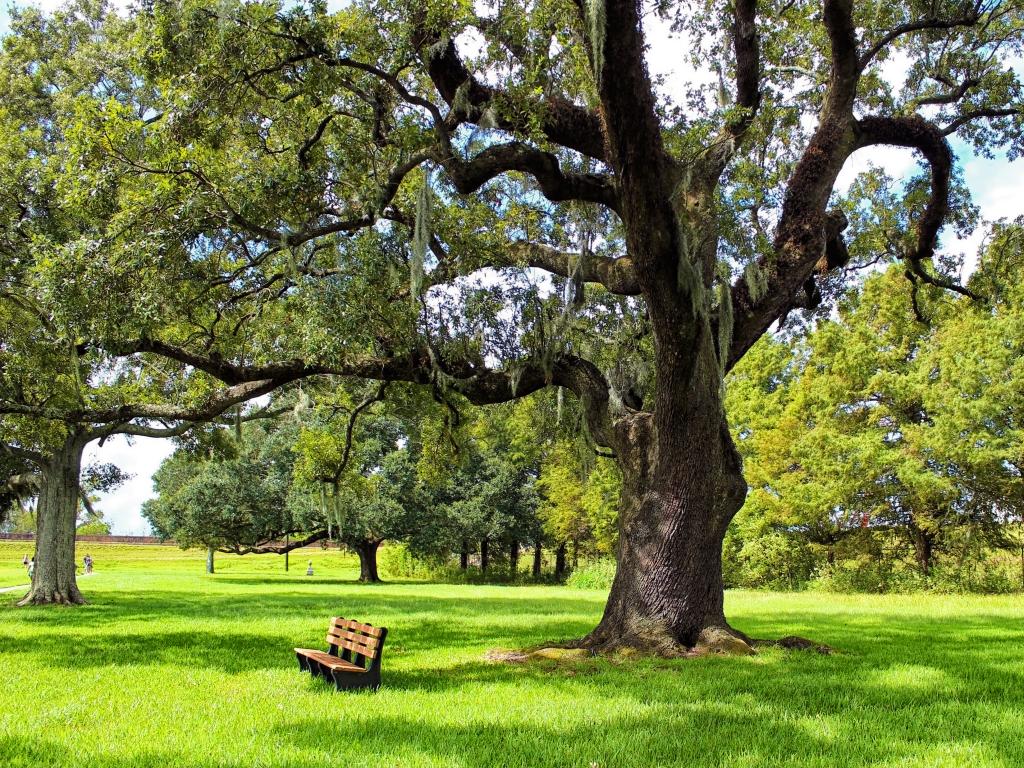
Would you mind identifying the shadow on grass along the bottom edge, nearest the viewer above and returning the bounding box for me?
[272,696,1021,766]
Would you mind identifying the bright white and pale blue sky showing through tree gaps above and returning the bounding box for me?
[0,0,1024,535]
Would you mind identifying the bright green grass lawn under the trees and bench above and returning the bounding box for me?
[0,543,1024,768]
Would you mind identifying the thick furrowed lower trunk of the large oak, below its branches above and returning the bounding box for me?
[584,345,750,652]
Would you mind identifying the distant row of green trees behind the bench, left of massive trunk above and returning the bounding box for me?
[143,381,618,582]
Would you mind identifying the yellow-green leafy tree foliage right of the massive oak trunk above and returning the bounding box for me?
[727,253,1024,578]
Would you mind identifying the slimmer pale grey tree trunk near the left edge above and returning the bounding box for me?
[18,433,87,605]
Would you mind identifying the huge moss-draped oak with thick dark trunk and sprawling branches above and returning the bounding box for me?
[9,0,1022,649]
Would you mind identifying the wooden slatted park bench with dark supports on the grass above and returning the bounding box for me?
[295,616,387,690]
